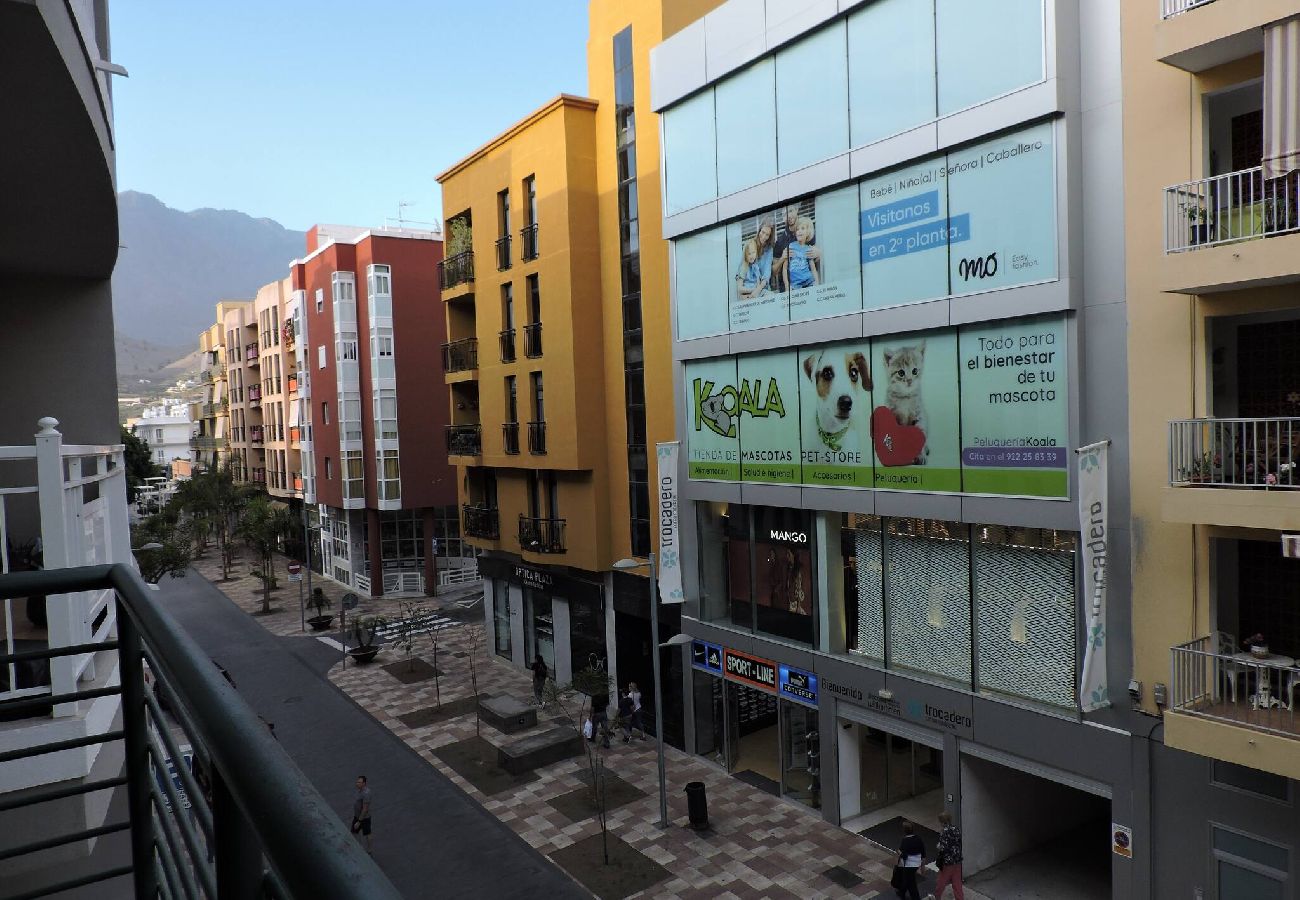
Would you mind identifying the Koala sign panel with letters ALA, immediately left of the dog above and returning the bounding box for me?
[736,350,800,484]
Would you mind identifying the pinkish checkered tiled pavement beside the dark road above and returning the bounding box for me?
[196,553,987,900]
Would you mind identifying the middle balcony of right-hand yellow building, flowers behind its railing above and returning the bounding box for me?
[1164,417,1300,529]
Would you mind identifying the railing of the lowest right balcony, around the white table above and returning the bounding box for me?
[1169,636,1300,737]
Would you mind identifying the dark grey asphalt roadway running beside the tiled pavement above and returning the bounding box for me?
[159,561,585,899]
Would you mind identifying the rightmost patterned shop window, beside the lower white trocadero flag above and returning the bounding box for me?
[974,525,1076,708]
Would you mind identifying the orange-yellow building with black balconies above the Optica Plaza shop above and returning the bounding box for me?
[438,0,718,739]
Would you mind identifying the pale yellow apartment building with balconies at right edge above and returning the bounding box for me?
[1122,0,1300,897]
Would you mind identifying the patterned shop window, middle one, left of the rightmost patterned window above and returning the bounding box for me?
[885,519,971,684]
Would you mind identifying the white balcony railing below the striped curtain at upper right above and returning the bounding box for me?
[1165,166,1300,254]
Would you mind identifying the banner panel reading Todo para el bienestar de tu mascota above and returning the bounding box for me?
[958,316,1070,497]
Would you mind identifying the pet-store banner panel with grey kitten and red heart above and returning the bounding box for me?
[871,330,962,492]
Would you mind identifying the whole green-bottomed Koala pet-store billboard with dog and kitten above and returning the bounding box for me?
[685,315,1070,498]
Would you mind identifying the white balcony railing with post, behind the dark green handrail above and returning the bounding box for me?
[0,419,131,717]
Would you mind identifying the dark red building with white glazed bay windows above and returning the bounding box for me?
[291,225,460,596]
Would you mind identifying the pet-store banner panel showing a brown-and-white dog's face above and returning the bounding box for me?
[798,338,874,488]
